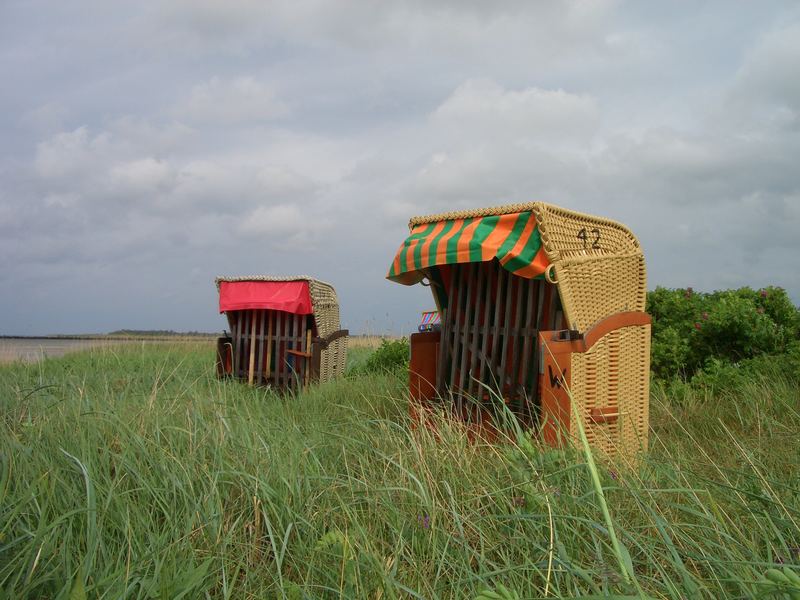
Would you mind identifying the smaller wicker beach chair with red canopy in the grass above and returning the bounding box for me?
[216,275,348,389]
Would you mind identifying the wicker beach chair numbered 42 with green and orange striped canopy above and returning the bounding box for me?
[387,202,650,456]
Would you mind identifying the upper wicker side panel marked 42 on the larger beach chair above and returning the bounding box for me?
[533,202,647,331]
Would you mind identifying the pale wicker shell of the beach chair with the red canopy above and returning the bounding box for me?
[215,275,347,381]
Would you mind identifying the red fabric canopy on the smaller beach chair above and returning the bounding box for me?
[219,281,314,315]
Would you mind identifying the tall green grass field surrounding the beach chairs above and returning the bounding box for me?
[0,344,800,600]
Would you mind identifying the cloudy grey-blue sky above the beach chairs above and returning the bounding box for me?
[0,0,800,335]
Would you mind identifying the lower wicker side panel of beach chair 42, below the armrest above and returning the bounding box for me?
[570,325,650,461]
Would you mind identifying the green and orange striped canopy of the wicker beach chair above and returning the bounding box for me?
[386,210,550,285]
